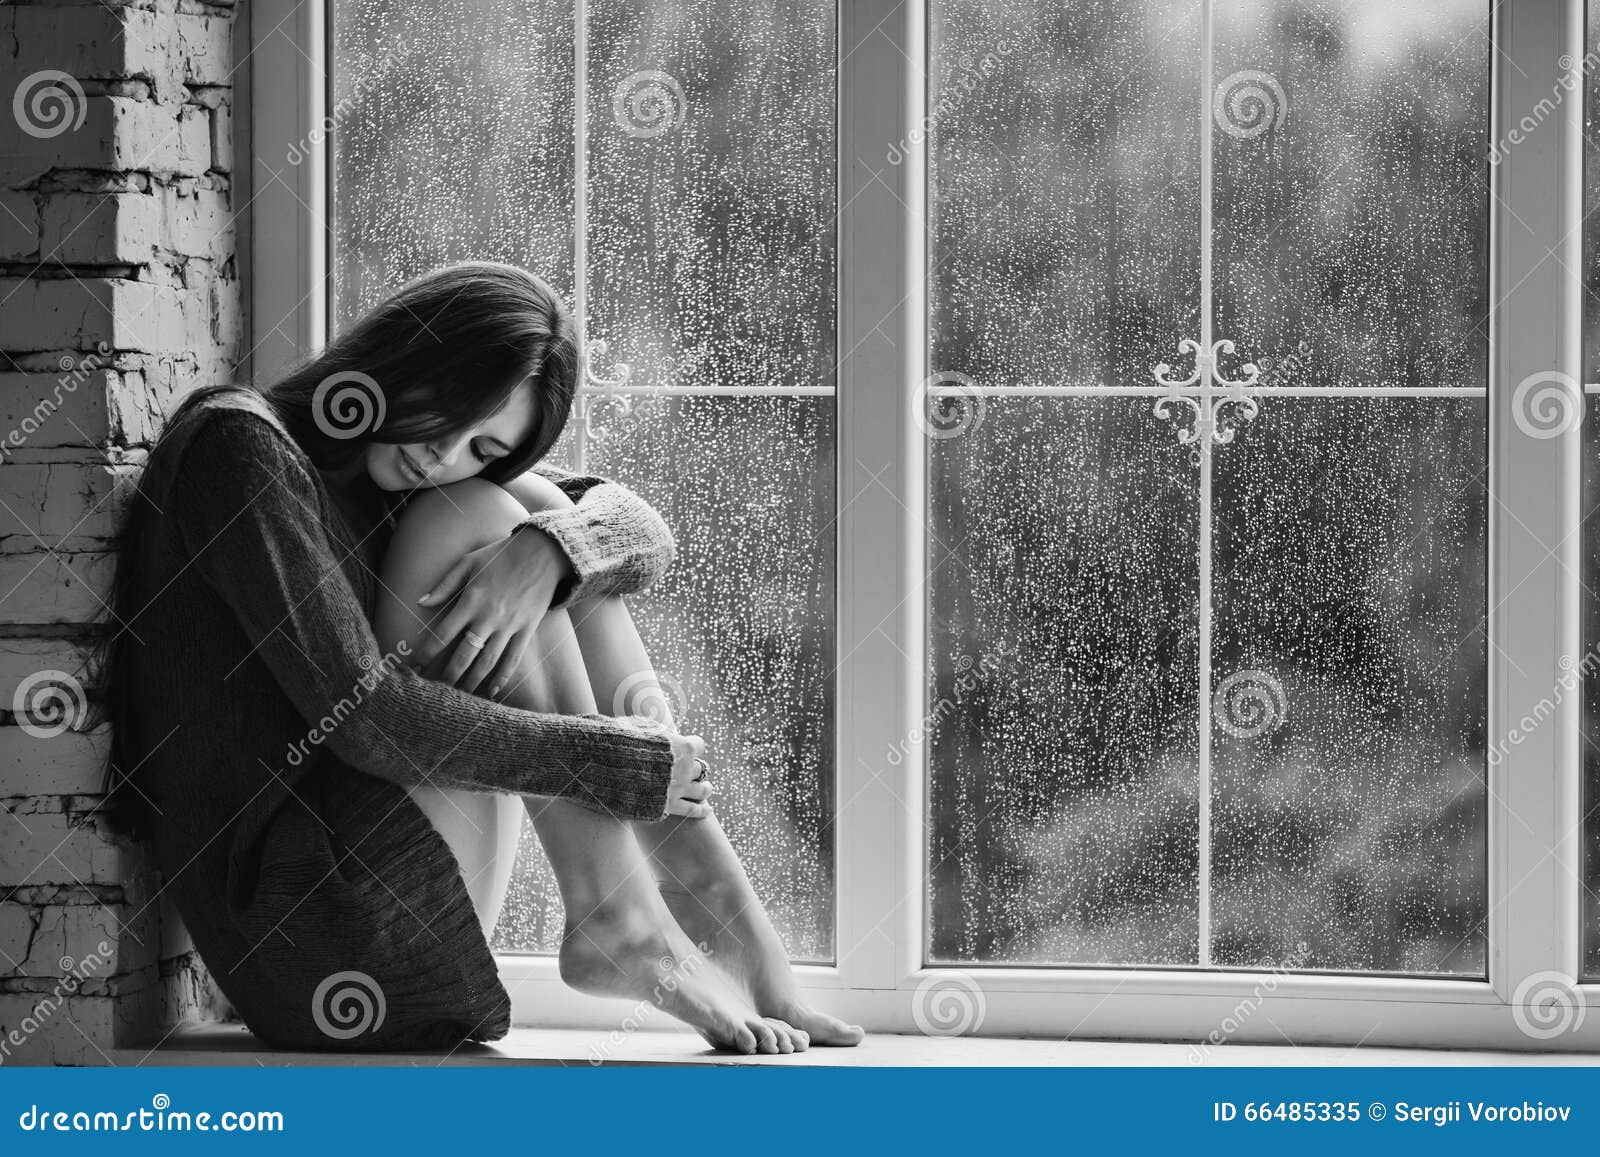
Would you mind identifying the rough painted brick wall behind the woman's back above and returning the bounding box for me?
[0,0,243,1064]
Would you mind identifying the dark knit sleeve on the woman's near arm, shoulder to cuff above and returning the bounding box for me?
[165,410,672,819]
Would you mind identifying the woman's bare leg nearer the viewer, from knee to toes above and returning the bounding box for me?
[378,480,806,1053]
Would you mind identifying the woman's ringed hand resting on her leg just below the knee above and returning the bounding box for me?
[416,526,571,699]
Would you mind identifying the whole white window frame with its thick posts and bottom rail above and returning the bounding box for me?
[248,0,1600,1050]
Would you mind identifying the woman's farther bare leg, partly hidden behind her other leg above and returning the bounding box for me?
[570,599,862,1047]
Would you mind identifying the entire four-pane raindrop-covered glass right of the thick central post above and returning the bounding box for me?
[926,0,1491,978]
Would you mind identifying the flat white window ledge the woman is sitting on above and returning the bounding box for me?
[110,1024,1600,1067]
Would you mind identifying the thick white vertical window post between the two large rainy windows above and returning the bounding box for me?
[835,0,926,987]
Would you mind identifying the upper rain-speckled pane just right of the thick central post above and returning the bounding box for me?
[928,0,1200,393]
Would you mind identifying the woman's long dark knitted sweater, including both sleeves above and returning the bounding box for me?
[130,390,672,1048]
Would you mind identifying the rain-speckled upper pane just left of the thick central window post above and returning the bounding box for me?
[587,0,835,386]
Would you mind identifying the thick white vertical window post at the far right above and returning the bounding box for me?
[1488,0,1584,1002]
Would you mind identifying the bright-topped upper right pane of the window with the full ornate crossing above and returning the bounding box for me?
[1211,0,1491,387]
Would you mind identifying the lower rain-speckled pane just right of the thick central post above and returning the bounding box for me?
[926,397,1198,965]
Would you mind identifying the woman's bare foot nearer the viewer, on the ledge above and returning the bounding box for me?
[560,906,810,1055]
